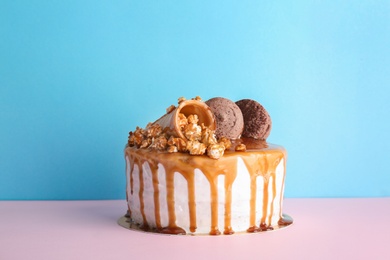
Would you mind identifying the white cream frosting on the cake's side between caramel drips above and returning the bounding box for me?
[126,155,285,234]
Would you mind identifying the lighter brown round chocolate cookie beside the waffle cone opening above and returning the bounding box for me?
[206,97,244,139]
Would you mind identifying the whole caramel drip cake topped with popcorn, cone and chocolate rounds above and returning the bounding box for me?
[119,97,292,235]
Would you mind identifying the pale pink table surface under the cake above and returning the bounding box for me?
[0,198,390,260]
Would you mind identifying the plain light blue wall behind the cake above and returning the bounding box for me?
[0,0,390,200]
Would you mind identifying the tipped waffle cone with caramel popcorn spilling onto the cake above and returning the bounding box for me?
[128,97,231,159]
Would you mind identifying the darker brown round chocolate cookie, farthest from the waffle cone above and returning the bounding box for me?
[236,99,272,140]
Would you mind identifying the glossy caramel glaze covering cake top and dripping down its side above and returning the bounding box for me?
[126,140,286,235]
